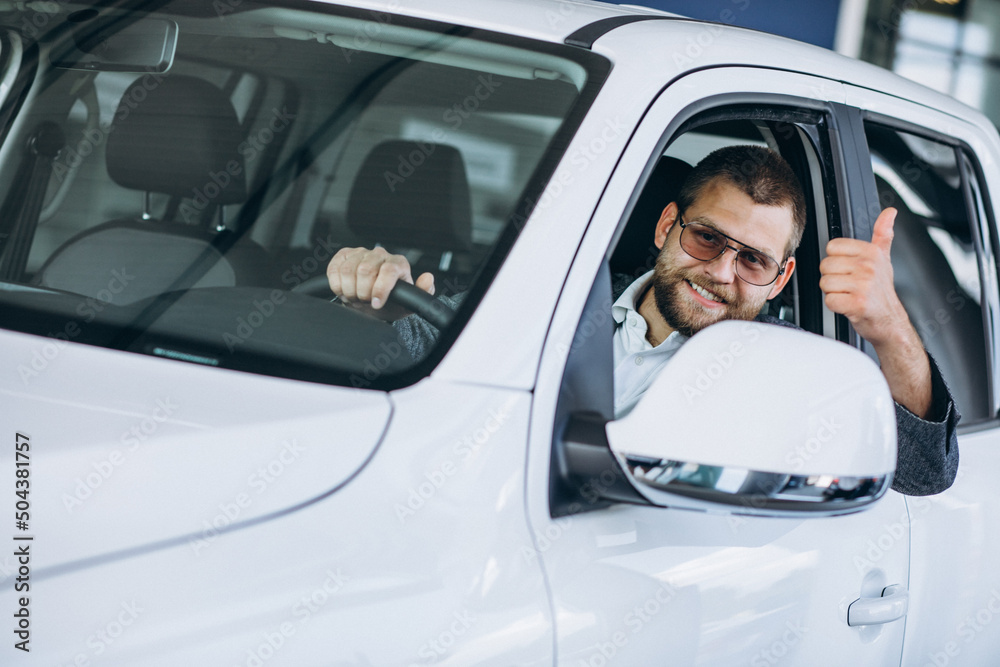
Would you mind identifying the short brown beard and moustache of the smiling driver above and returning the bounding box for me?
[652,246,767,337]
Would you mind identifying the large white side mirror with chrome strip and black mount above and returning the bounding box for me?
[557,321,896,517]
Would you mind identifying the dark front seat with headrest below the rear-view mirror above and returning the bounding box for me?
[34,75,267,305]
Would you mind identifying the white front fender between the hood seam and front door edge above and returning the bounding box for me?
[9,380,552,666]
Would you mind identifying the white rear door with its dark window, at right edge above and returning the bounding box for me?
[847,81,1000,666]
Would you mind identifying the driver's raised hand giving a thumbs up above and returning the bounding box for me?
[819,208,913,349]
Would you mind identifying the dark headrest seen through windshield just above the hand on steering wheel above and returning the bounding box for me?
[347,140,472,251]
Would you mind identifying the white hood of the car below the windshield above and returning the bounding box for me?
[0,331,391,570]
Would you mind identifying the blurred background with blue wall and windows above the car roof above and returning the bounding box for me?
[604,0,1000,125]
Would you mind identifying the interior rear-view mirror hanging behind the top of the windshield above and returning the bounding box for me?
[51,9,177,73]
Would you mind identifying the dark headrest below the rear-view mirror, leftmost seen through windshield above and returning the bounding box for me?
[107,75,247,205]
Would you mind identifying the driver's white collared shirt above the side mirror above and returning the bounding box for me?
[611,271,688,419]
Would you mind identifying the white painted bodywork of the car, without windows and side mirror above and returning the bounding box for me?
[0,0,1000,667]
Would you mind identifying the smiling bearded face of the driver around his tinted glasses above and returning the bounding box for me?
[652,179,795,336]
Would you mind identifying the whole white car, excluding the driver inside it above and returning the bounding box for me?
[0,0,1000,667]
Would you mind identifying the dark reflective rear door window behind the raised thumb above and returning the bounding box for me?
[866,123,990,422]
